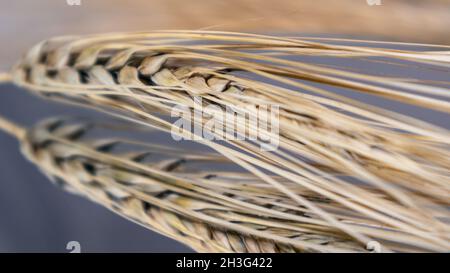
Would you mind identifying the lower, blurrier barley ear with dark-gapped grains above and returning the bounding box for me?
[2,118,372,252]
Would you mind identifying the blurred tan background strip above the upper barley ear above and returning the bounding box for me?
[0,0,450,69]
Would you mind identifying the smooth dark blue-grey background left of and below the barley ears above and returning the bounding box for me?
[0,84,192,252]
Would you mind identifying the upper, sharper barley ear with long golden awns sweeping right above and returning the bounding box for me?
[0,31,450,251]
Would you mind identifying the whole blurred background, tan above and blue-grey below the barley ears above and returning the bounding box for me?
[0,0,450,252]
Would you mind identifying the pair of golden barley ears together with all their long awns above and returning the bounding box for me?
[0,31,450,252]
